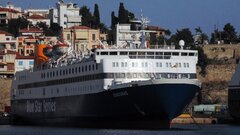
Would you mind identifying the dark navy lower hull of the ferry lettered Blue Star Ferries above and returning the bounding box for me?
[12,80,200,128]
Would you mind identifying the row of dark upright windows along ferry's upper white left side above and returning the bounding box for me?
[41,64,98,79]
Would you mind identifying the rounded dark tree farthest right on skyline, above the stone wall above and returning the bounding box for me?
[223,23,237,44]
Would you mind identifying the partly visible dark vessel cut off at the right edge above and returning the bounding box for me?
[228,63,240,122]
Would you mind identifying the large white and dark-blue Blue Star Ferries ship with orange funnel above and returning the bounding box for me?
[11,16,201,128]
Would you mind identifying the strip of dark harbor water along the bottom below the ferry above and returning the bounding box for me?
[0,124,240,135]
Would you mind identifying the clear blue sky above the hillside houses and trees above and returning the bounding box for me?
[0,0,240,35]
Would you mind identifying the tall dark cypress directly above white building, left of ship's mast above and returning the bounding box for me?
[118,3,129,24]
